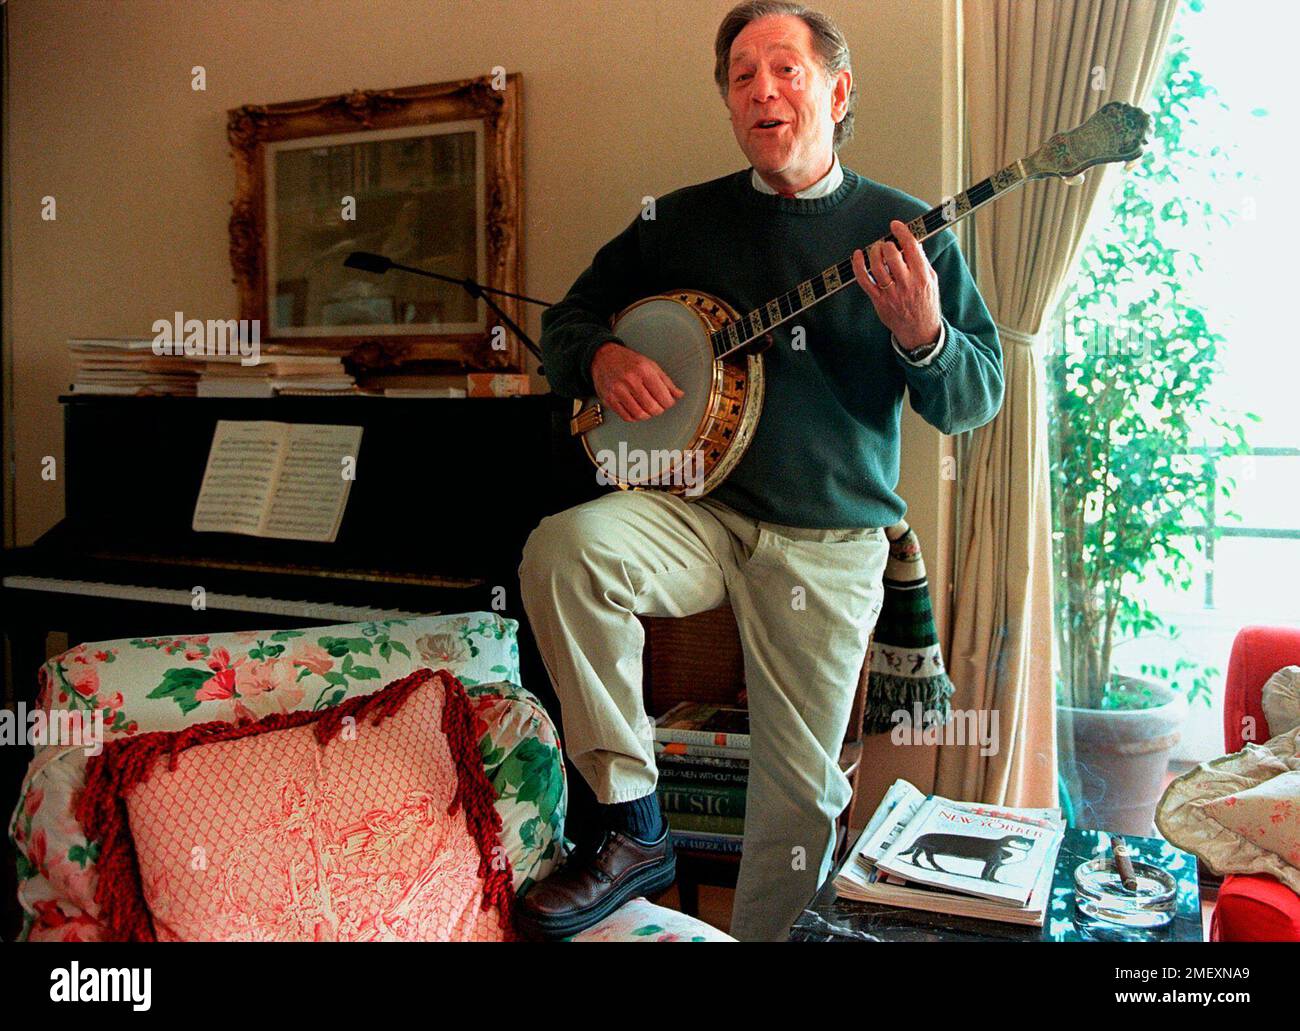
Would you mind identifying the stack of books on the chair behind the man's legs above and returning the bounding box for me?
[654,702,749,854]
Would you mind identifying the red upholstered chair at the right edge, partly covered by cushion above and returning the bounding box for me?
[1210,627,1300,941]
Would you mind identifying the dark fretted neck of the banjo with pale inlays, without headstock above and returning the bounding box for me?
[709,159,1031,359]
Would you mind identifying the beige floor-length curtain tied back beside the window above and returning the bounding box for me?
[935,0,1175,806]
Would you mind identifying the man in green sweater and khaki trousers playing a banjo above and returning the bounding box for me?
[520,0,1002,940]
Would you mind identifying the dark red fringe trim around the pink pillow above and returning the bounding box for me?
[75,670,516,941]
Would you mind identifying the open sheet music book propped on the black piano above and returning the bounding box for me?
[192,419,363,542]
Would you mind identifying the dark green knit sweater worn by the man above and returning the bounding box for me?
[542,168,1002,528]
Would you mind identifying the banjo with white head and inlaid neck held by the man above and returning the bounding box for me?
[569,101,1151,498]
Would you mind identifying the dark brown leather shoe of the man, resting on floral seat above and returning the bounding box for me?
[515,826,677,939]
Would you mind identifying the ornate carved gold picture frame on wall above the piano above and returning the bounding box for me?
[226,73,524,372]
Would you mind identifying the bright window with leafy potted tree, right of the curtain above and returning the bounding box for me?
[1045,0,1300,833]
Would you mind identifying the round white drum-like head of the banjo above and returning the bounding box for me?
[584,296,715,488]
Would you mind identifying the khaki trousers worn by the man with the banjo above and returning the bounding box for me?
[520,491,889,941]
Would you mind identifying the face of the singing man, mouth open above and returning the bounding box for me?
[727,14,853,190]
